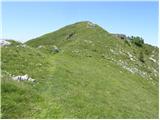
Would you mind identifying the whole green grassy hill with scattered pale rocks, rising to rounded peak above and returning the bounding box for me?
[1,21,159,118]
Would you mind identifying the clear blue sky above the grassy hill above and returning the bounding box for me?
[2,1,158,45]
